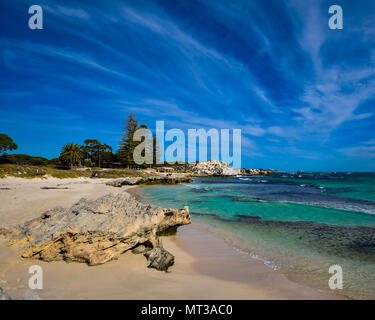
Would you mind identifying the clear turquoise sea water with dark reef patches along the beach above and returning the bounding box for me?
[140,173,375,299]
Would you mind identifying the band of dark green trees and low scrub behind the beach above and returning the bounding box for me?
[0,114,191,178]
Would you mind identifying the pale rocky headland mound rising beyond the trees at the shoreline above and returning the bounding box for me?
[188,160,240,176]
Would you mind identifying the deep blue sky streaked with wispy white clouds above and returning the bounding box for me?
[0,0,375,171]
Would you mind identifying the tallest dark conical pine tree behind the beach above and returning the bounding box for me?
[118,113,139,168]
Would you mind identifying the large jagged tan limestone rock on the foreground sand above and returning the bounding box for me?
[2,193,191,270]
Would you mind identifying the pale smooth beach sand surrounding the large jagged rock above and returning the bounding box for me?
[0,178,339,299]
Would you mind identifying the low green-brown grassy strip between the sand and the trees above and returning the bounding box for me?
[0,164,154,179]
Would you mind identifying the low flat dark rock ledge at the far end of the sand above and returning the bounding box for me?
[106,176,193,188]
